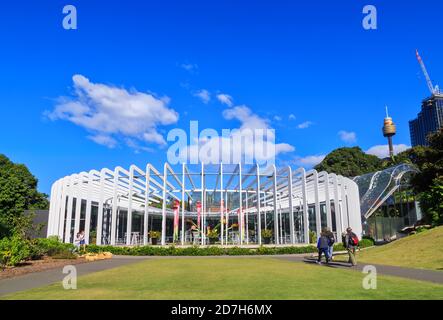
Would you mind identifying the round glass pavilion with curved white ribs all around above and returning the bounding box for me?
[48,163,362,246]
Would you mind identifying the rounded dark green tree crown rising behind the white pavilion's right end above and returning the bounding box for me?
[315,147,383,177]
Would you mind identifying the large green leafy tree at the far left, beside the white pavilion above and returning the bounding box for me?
[0,154,49,237]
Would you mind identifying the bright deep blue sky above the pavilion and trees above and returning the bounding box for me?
[0,0,443,193]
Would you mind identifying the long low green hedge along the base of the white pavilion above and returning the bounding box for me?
[86,239,374,256]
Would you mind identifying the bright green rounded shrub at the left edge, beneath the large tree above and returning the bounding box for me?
[0,236,31,267]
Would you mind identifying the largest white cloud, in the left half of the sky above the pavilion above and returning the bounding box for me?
[47,75,179,148]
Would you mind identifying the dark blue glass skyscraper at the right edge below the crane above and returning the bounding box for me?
[409,93,443,147]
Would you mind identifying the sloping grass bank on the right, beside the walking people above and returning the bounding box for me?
[339,227,443,270]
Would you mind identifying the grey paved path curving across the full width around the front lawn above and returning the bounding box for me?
[0,254,443,297]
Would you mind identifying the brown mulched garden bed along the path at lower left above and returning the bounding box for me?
[0,257,87,280]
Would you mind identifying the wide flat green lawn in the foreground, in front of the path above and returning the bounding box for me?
[3,257,443,300]
